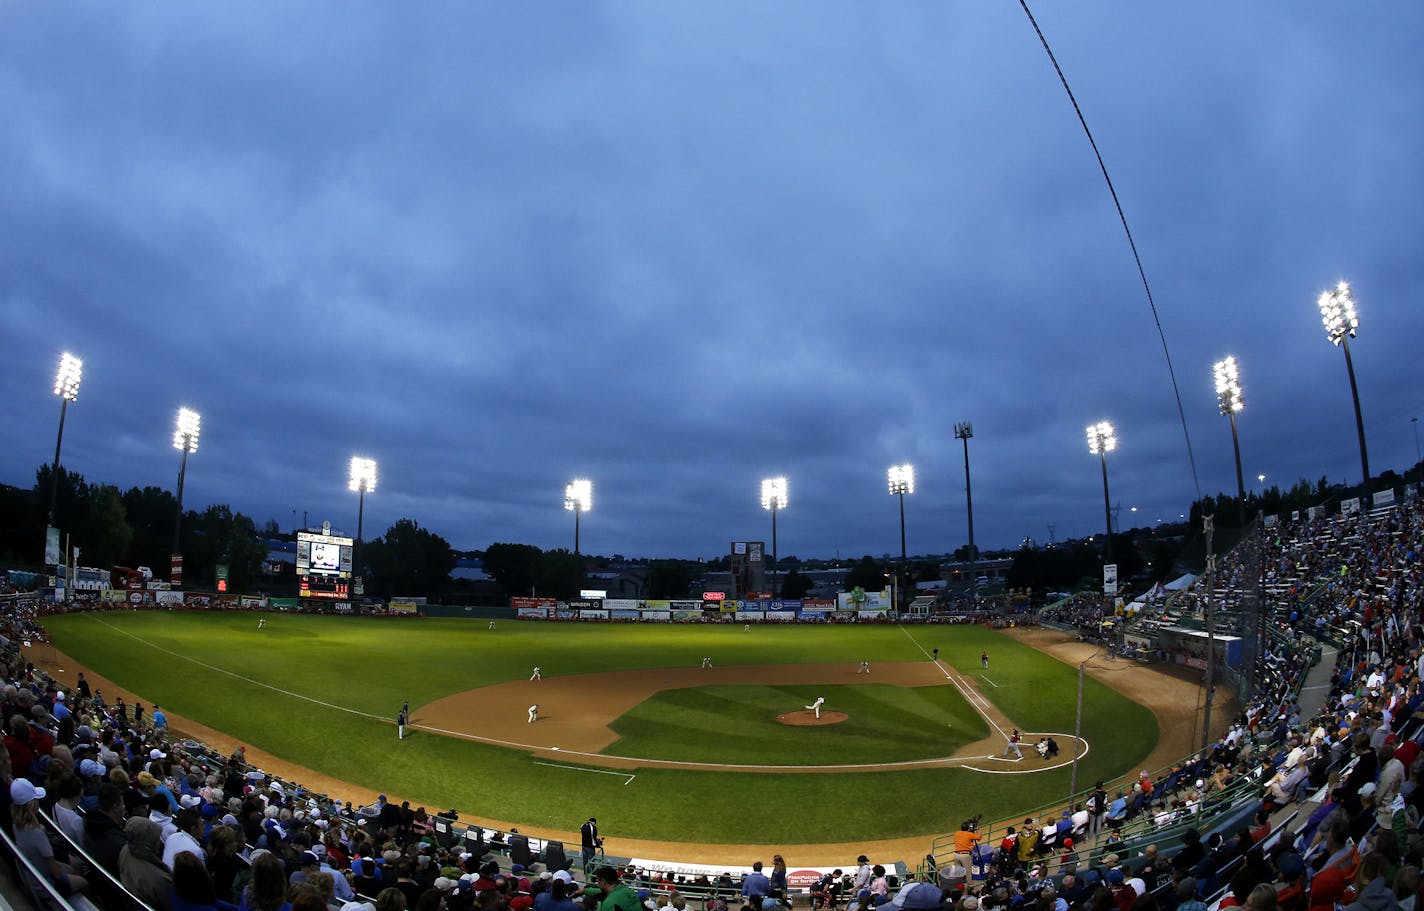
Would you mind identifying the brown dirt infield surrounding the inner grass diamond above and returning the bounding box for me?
[410,660,1087,774]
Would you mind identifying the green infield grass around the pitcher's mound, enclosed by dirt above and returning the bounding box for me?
[604,683,988,766]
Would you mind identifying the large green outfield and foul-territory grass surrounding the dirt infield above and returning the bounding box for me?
[50,612,1158,844]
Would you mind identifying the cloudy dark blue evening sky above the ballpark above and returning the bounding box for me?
[0,0,1424,557]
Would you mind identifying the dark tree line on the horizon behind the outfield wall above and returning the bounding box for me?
[8,463,1424,604]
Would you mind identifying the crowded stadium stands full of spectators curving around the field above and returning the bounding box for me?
[0,501,1424,911]
